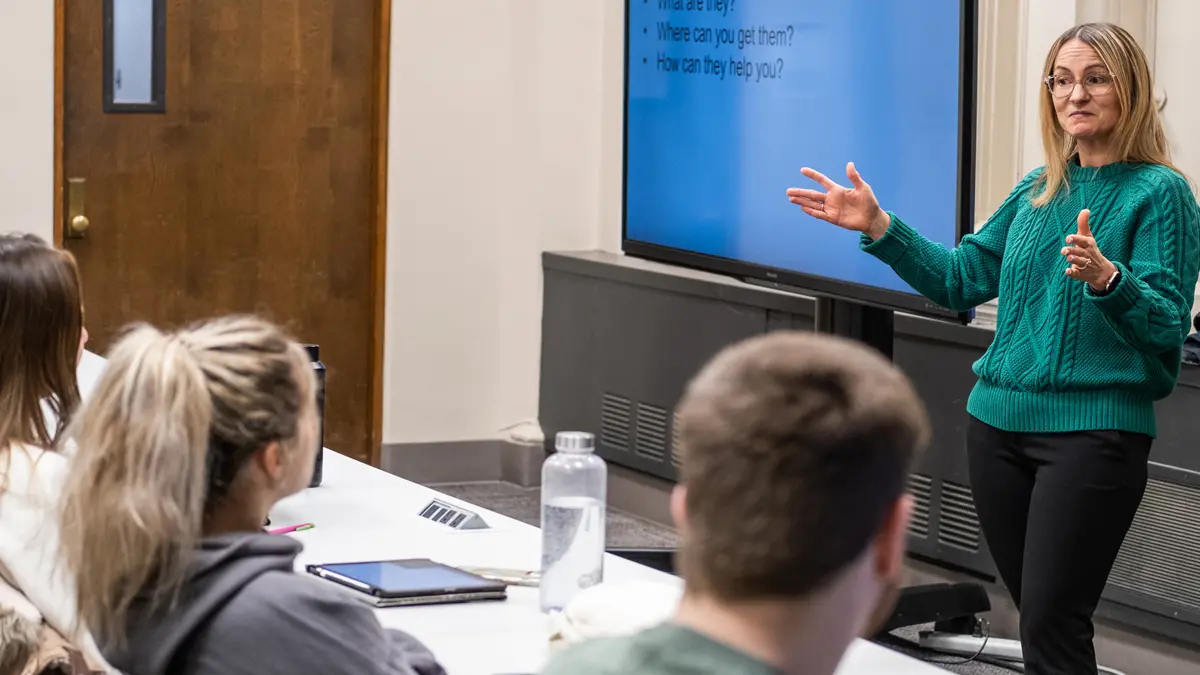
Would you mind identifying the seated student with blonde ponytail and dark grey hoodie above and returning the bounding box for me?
[62,317,442,675]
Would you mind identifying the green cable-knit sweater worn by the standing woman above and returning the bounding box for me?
[862,163,1200,436]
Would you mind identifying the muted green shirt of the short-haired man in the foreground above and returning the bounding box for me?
[542,623,779,675]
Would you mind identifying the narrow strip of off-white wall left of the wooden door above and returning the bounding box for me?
[0,0,54,240]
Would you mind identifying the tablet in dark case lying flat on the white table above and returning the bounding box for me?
[306,558,508,608]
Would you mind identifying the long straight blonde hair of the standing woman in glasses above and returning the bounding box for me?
[1033,23,1182,207]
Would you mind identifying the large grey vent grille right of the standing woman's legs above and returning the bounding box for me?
[1109,478,1200,610]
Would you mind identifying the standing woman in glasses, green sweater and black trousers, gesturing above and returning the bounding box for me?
[787,24,1200,675]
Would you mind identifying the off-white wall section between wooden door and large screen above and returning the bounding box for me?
[384,0,623,443]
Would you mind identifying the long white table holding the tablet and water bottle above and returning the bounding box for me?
[271,450,944,675]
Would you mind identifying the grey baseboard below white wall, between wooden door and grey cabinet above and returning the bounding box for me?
[379,438,546,488]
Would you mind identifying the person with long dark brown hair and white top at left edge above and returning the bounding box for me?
[0,229,103,667]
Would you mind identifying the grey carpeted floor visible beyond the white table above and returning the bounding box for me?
[430,483,1019,675]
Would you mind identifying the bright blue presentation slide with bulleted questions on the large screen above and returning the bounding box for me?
[625,0,962,293]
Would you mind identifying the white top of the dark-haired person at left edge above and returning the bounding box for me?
[0,446,104,663]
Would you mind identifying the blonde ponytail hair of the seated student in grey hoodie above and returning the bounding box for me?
[61,317,316,644]
